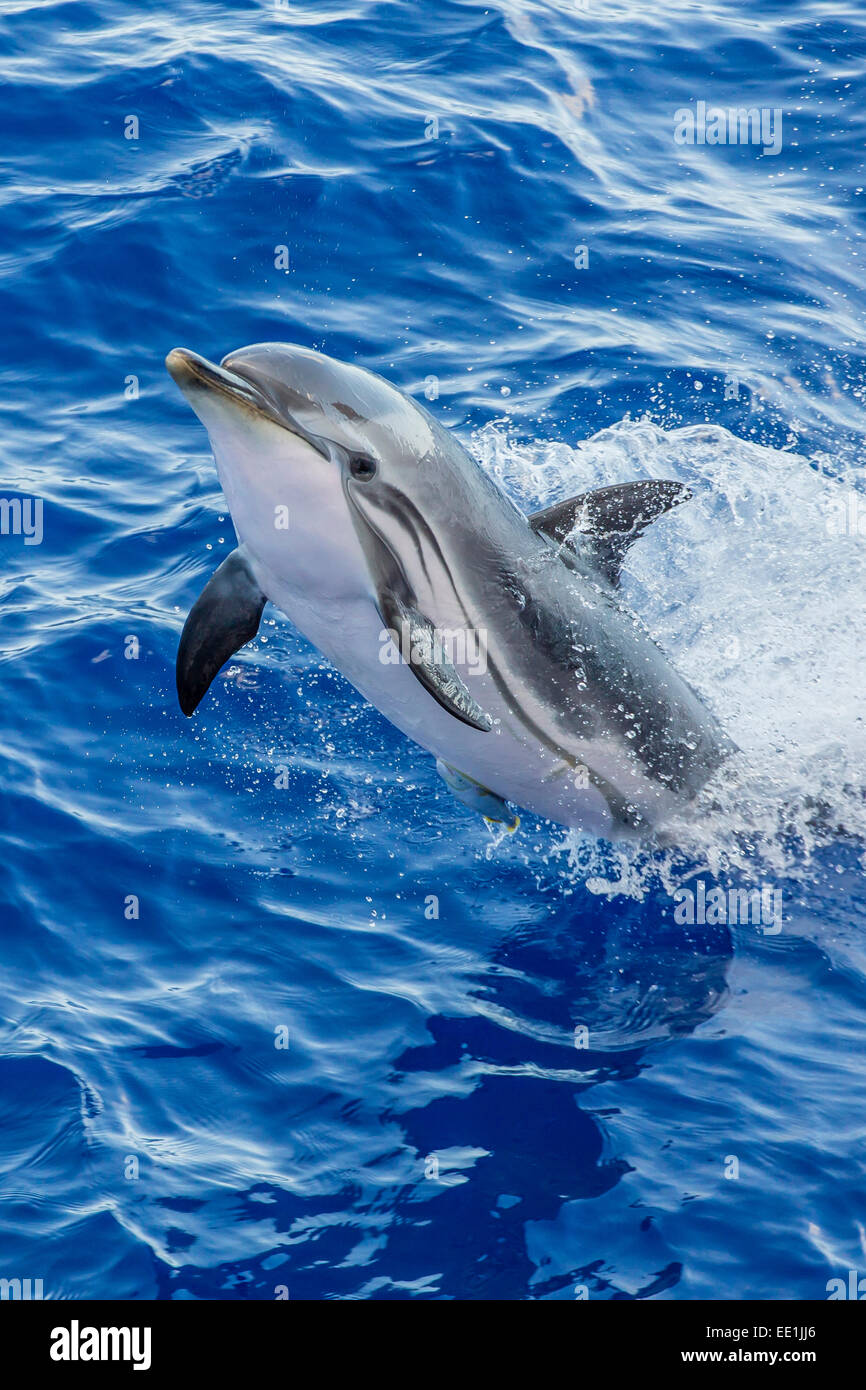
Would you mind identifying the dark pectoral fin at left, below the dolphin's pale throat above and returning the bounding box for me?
[177,549,267,716]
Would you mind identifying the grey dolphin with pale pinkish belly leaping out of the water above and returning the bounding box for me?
[165,343,734,838]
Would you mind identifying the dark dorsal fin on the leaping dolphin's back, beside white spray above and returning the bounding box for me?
[528,478,692,584]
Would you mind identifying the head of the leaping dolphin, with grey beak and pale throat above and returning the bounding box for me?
[165,343,459,598]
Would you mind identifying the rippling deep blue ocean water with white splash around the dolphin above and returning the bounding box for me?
[0,0,866,1300]
